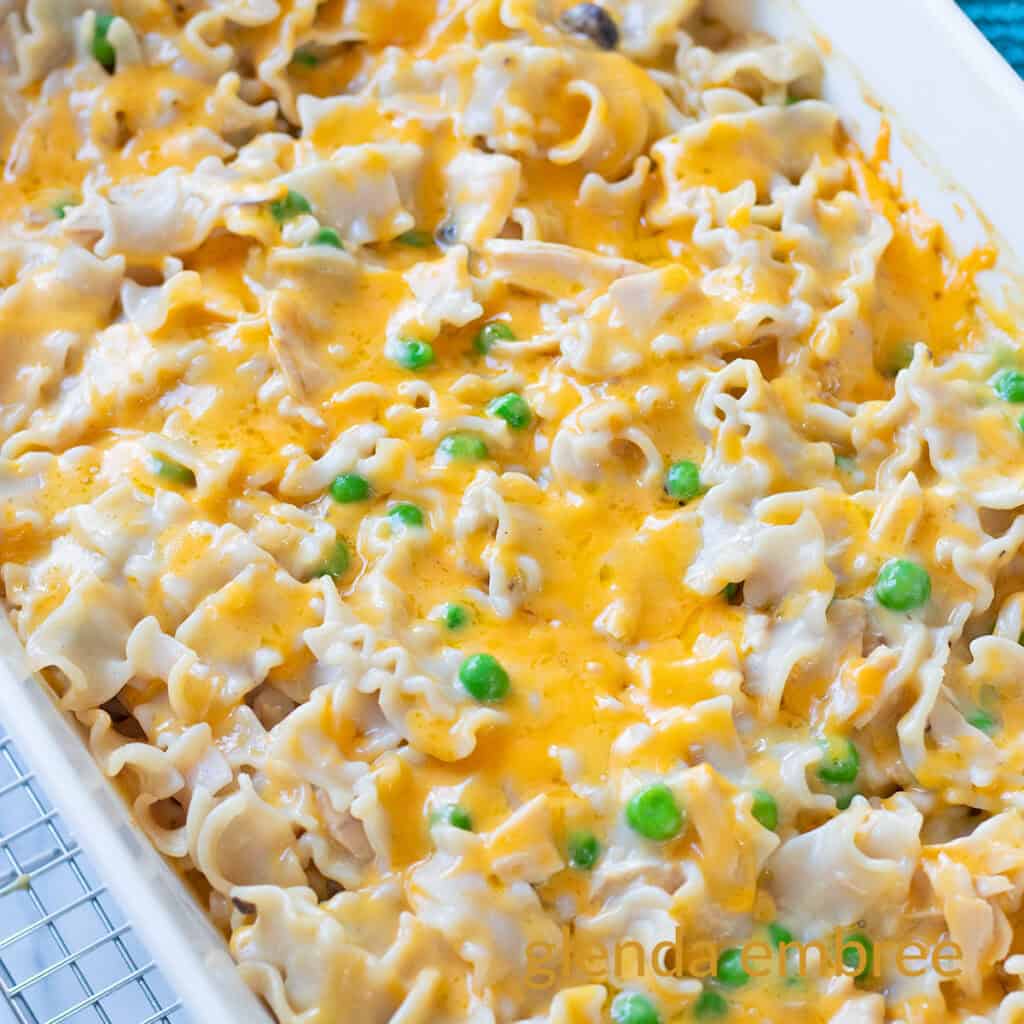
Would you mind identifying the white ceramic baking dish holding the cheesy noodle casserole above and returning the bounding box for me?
[0,0,1024,1024]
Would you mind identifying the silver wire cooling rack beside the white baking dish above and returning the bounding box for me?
[0,727,188,1024]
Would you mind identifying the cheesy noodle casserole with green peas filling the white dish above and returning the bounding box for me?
[0,0,1024,1024]
